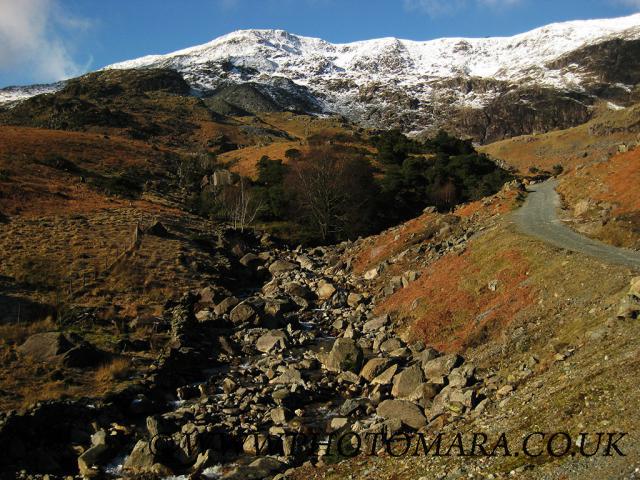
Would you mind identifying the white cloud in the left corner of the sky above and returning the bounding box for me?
[0,0,89,82]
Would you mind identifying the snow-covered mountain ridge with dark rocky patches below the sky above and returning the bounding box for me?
[0,14,640,141]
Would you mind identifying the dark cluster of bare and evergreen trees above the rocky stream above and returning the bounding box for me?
[189,131,510,243]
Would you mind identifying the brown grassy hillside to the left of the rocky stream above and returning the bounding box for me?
[0,127,225,409]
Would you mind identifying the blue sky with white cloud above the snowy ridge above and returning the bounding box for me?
[0,0,640,87]
